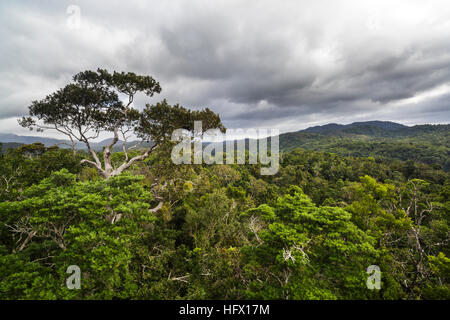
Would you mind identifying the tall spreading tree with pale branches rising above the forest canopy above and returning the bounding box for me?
[19,69,223,179]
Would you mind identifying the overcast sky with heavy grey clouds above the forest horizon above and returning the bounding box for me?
[0,0,450,136]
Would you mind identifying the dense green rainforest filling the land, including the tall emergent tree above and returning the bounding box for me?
[0,70,450,299]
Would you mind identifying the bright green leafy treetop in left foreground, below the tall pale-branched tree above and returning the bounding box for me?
[0,169,156,298]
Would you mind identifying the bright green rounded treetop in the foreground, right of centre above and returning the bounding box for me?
[242,187,379,299]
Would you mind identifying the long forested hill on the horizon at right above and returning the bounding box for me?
[280,121,450,171]
